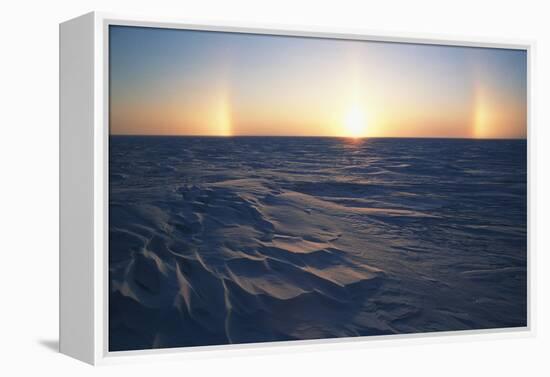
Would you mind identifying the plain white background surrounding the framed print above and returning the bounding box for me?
[0,0,550,376]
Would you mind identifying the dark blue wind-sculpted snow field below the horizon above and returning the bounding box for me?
[109,136,527,351]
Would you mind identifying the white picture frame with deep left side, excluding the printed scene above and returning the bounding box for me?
[59,12,534,364]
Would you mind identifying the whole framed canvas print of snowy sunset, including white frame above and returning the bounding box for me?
[60,13,531,363]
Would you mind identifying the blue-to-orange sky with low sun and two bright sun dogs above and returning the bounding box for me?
[109,26,527,138]
